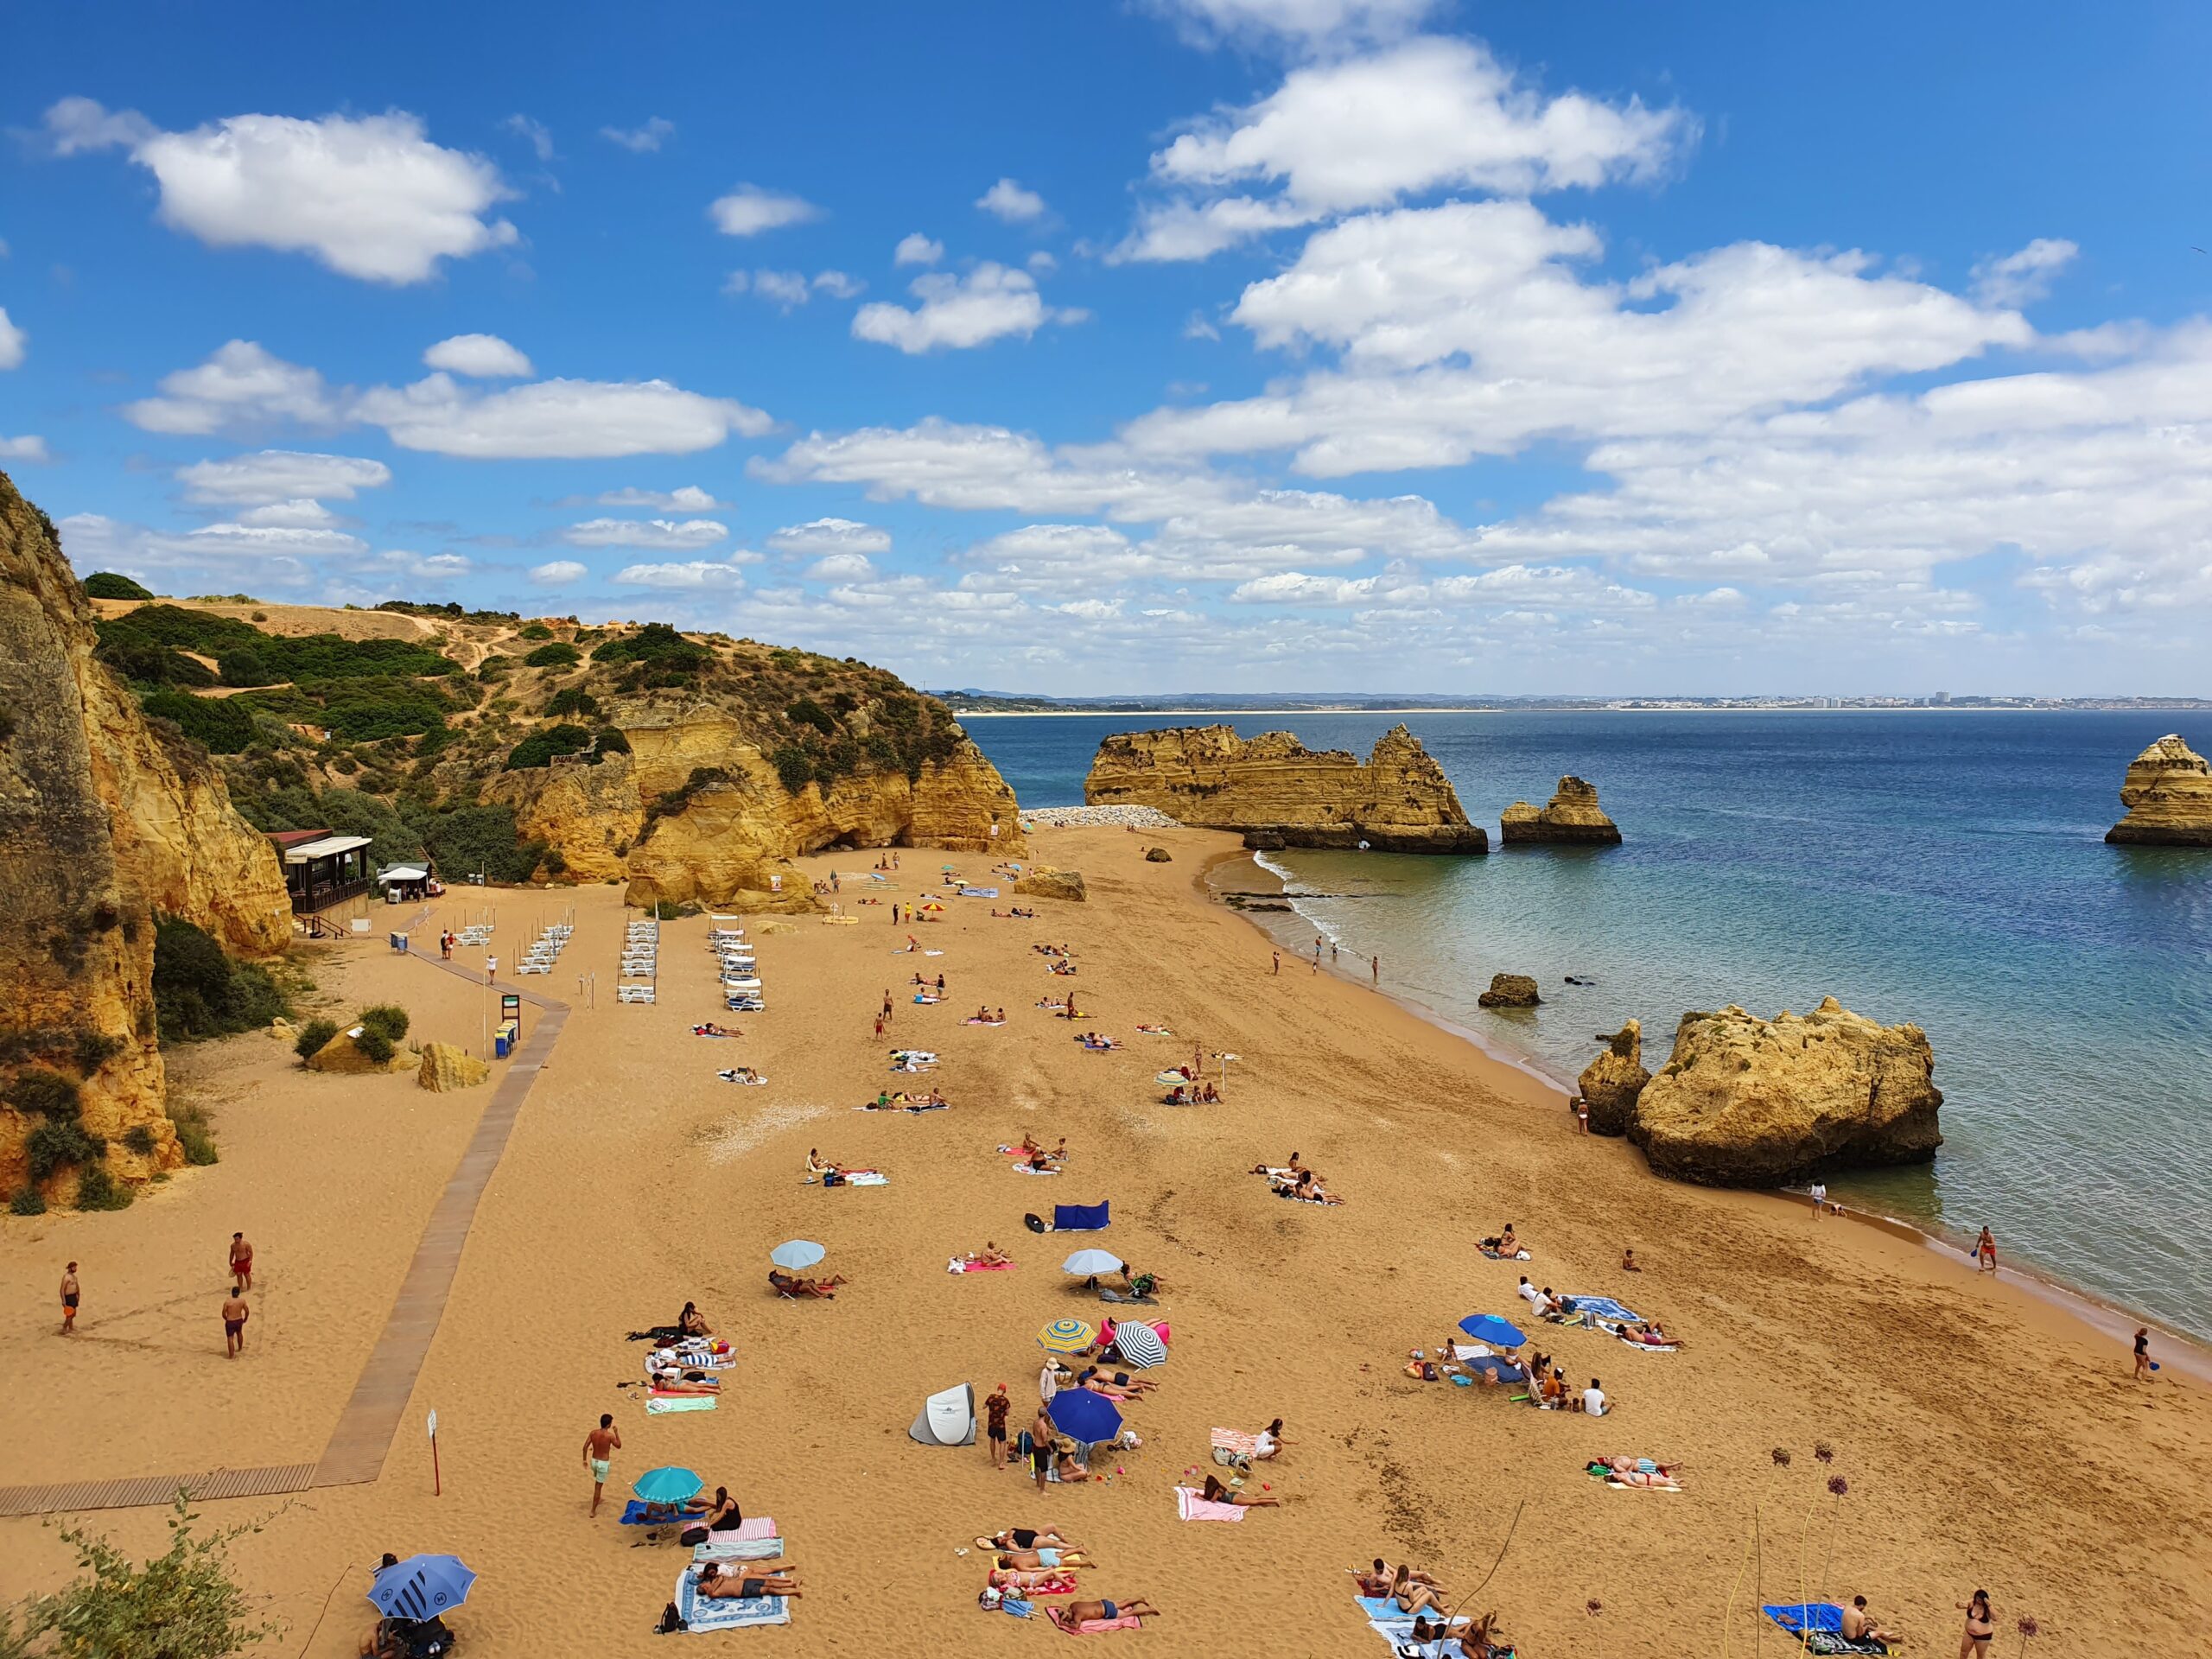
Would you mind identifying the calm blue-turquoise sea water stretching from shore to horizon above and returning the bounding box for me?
[969,712,2212,1338]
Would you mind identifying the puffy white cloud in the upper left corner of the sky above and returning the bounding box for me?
[47,98,518,283]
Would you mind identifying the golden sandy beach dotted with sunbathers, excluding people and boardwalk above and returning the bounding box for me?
[0,830,2212,1659]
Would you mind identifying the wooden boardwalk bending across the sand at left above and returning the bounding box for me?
[0,953,569,1516]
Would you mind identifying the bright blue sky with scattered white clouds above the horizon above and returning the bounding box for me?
[0,0,2212,692]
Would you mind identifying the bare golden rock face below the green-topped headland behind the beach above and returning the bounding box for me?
[491,703,1027,909]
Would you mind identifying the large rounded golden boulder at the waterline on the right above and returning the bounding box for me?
[1628,998,1942,1185]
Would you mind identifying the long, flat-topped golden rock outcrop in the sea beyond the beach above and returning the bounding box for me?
[1084,726,1489,854]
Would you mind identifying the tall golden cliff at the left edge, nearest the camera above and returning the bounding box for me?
[0,474,274,1197]
